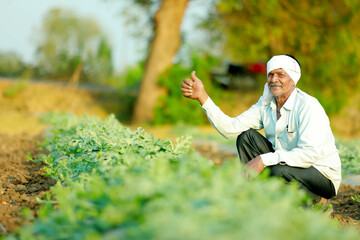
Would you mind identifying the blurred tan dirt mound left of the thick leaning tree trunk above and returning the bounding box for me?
[0,78,122,135]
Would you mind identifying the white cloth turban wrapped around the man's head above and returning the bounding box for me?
[266,55,301,85]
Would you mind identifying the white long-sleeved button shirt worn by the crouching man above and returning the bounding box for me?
[202,86,341,192]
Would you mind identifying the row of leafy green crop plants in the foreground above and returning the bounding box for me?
[6,115,359,240]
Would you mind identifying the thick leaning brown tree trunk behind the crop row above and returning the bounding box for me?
[132,0,189,124]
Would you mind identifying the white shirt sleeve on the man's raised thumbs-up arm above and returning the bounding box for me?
[201,97,263,138]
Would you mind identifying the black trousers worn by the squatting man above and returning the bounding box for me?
[236,129,336,199]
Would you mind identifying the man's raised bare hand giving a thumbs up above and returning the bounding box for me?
[181,71,209,105]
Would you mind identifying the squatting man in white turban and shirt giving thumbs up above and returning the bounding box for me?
[181,55,341,210]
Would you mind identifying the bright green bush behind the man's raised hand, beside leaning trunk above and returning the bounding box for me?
[154,53,222,125]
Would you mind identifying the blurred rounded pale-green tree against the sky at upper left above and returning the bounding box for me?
[37,9,112,83]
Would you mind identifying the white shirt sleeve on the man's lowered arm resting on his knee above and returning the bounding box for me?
[261,97,333,168]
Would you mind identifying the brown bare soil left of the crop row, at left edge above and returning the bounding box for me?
[0,134,55,234]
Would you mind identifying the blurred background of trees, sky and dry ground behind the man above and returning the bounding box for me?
[0,0,360,138]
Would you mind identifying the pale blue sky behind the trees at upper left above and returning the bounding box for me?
[0,0,207,71]
